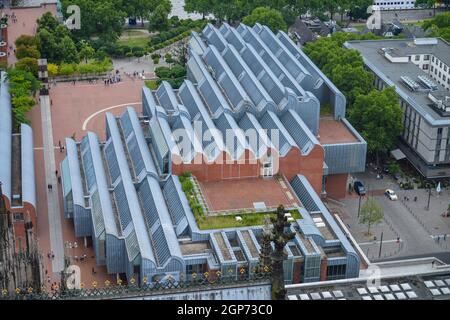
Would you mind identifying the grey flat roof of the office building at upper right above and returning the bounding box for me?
[347,39,450,123]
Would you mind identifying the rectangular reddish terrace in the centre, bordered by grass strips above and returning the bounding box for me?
[200,178,299,212]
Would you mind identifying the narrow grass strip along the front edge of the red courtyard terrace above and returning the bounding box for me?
[196,210,303,230]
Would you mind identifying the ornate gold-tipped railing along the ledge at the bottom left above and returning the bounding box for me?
[0,268,270,300]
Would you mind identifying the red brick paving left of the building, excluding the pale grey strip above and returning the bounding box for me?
[29,79,143,287]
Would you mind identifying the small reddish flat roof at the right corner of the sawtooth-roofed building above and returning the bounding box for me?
[319,117,360,144]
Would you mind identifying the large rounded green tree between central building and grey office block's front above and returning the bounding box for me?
[349,88,403,165]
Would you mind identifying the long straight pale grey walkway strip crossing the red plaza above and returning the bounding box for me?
[40,96,64,272]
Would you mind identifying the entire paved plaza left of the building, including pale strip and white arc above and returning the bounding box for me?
[29,78,144,288]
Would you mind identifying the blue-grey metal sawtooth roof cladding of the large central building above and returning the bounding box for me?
[63,24,370,281]
